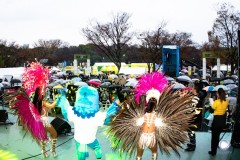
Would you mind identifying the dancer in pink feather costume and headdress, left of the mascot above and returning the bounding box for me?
[4,62,57,158]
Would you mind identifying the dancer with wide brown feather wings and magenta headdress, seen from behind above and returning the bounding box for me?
[107,72,194,160]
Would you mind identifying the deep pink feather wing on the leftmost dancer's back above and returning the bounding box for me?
[5,88,48,142]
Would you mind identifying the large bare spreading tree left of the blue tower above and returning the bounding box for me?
[82,13,133,70]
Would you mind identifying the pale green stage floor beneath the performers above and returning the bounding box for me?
[0,107,240,160]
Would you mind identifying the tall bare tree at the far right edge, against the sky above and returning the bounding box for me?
[209,3,240,74]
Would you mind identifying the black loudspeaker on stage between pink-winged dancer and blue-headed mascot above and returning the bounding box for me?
[51,117,71,134]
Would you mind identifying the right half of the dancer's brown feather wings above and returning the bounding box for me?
[156,87,194,156]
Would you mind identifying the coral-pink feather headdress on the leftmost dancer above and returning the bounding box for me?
[22,62,49,96]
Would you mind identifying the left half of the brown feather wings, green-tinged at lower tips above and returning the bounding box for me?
[107,98,144,157]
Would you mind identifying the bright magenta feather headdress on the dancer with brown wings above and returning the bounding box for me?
[135,72,168,103]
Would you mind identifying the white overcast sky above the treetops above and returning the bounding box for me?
[0,0,240,46]
